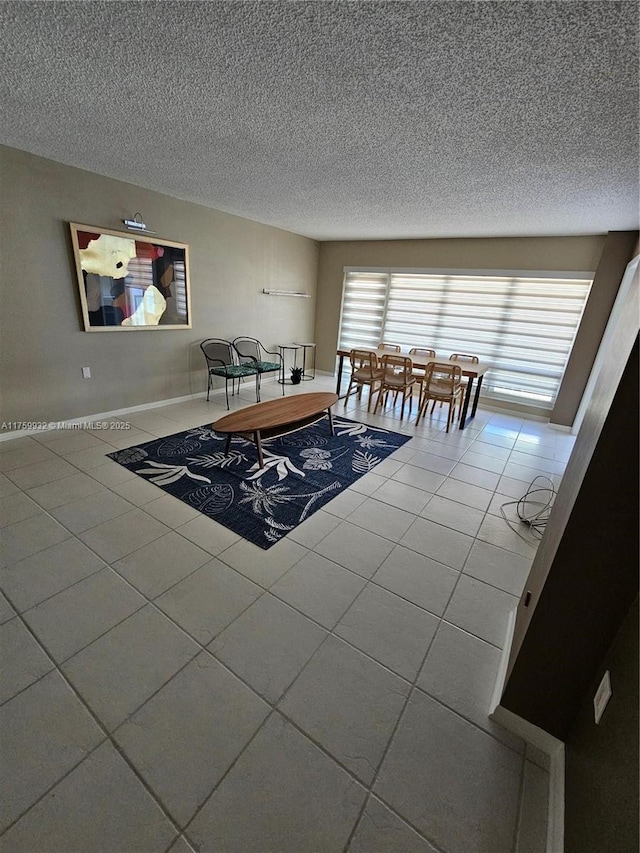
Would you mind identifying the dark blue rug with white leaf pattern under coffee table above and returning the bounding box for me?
[108,415,410,549]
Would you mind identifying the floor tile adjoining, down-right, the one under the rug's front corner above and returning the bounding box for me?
[271,553,366,629]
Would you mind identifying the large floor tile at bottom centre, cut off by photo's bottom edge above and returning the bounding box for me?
[188,715,365,853]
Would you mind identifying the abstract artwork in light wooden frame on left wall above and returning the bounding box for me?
[70,222,191,332]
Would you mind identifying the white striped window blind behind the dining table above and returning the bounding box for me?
[340,271,591,408]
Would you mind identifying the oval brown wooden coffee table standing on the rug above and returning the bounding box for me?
[211,391,338,468]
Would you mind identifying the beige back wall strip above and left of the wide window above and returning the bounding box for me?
[316,234,605,371]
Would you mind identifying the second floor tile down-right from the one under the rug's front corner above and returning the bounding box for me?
[334,584,438,681]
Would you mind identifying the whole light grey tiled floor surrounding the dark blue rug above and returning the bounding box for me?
[0,376,573,853]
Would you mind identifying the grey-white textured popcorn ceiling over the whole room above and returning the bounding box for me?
[0,0,638,240]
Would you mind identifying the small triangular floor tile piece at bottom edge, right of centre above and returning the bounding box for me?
[348,797,437,853]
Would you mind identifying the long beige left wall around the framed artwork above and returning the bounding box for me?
[0,148,318,430]
